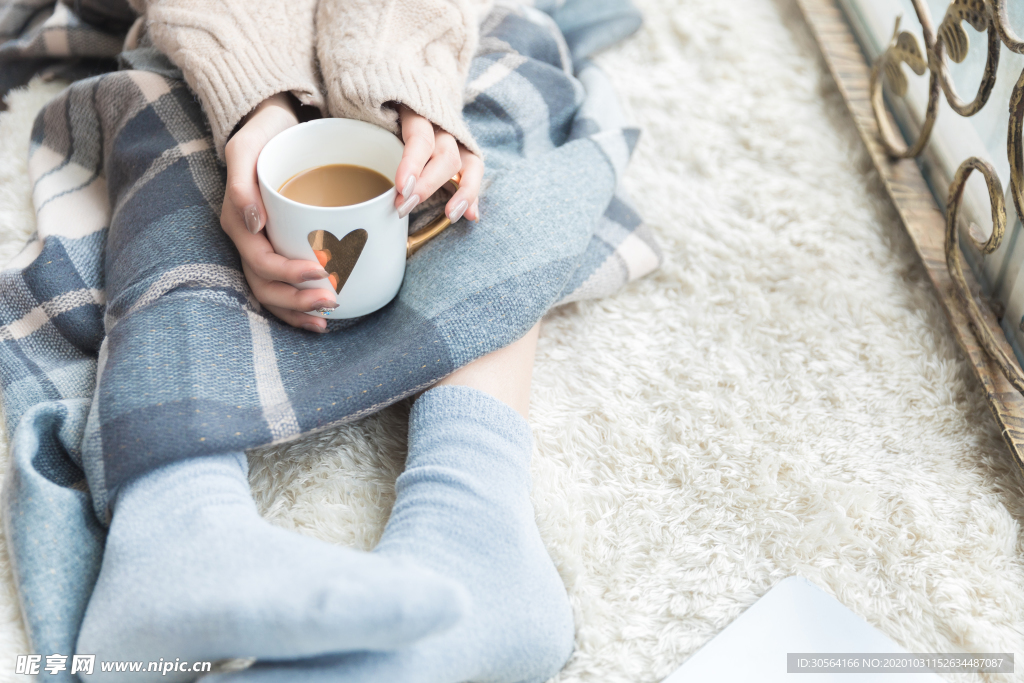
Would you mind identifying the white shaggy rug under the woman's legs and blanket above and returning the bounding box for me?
[0,0,1024,683]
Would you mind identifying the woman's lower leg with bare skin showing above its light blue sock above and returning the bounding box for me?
[209,328,573,683]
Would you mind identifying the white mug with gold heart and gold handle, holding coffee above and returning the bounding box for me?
[256,119,458,318]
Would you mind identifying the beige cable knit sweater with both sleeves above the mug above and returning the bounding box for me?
[131,0,489,158]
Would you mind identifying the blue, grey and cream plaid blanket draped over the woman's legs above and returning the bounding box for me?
[0,0,660,667]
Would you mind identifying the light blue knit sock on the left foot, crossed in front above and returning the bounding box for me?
[78,453,467,681]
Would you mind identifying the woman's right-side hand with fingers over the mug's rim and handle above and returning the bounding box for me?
[394,104,483,223]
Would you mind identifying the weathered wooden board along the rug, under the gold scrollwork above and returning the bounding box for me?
[797,0,1024,473]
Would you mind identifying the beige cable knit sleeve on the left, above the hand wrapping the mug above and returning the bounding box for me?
[131,0,325,159]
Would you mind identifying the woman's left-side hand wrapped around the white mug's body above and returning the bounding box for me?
[220,93,338,332]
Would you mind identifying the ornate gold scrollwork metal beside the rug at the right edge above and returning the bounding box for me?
[870,0,1024,393]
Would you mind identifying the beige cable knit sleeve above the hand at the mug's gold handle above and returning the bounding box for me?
[316,0,485,154]
